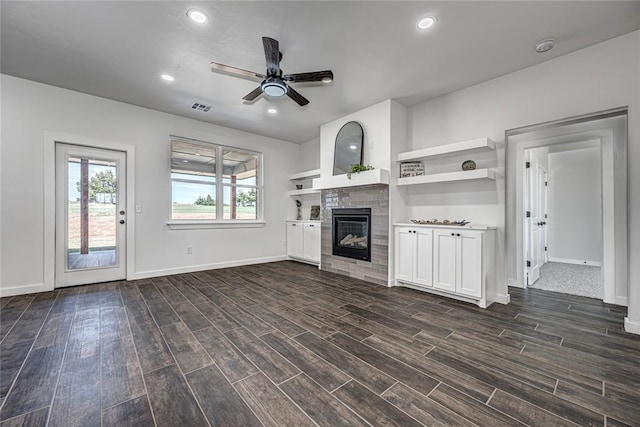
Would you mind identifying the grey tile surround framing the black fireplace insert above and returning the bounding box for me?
[320,185,389,286]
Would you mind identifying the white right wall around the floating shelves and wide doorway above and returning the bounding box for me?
[406,31,640,333]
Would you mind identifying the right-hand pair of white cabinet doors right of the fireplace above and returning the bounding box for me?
[433,229,484,298]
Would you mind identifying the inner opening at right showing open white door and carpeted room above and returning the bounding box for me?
[522,140,606,300]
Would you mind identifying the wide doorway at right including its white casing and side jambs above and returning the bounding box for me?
[506,108,628,306]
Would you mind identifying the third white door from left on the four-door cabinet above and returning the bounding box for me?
[433,229,456,292]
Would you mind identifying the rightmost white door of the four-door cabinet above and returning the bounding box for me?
[456,231,482,298]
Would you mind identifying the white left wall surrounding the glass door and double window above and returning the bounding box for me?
[0,75,299,294]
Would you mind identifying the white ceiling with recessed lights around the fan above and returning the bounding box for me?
[0,0,640,143]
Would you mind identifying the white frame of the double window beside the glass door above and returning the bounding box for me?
[167,135,265,229]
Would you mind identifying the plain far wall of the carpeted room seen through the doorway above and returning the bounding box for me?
[547,147,602,264]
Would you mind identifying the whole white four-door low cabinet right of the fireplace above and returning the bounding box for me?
[395,224,495,307]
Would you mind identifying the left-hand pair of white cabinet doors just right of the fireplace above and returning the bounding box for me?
[396,227,433,287]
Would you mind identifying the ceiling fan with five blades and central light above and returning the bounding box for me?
[211,37,333,107]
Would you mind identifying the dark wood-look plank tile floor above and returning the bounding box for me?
[0,262,640,427]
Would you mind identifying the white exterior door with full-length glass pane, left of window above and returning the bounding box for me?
[55,144,127,287]
